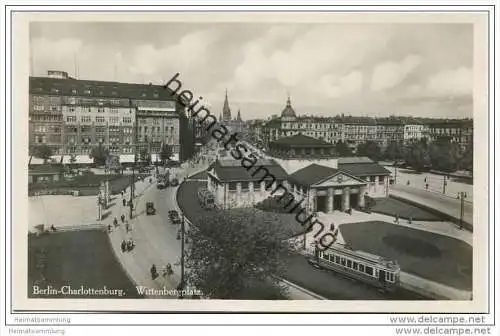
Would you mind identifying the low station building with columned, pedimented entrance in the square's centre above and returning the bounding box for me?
[203,135,390,213]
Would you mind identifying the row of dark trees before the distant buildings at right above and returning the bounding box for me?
[335,138,473,172]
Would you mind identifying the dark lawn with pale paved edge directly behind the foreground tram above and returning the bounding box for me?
[340,221,473,300]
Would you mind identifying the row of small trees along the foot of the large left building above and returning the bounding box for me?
[30,144,173,166]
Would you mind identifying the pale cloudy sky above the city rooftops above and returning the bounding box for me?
[30,22,473,119]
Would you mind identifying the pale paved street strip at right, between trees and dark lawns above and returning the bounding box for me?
[389,185,473,225]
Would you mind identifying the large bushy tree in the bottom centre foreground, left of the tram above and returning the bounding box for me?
[186,209,290,300]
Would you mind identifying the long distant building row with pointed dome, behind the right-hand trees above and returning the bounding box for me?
[258,97,473,149]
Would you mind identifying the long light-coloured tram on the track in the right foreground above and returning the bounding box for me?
[308,243,401,292]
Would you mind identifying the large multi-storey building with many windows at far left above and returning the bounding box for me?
[29,71,189,164]
